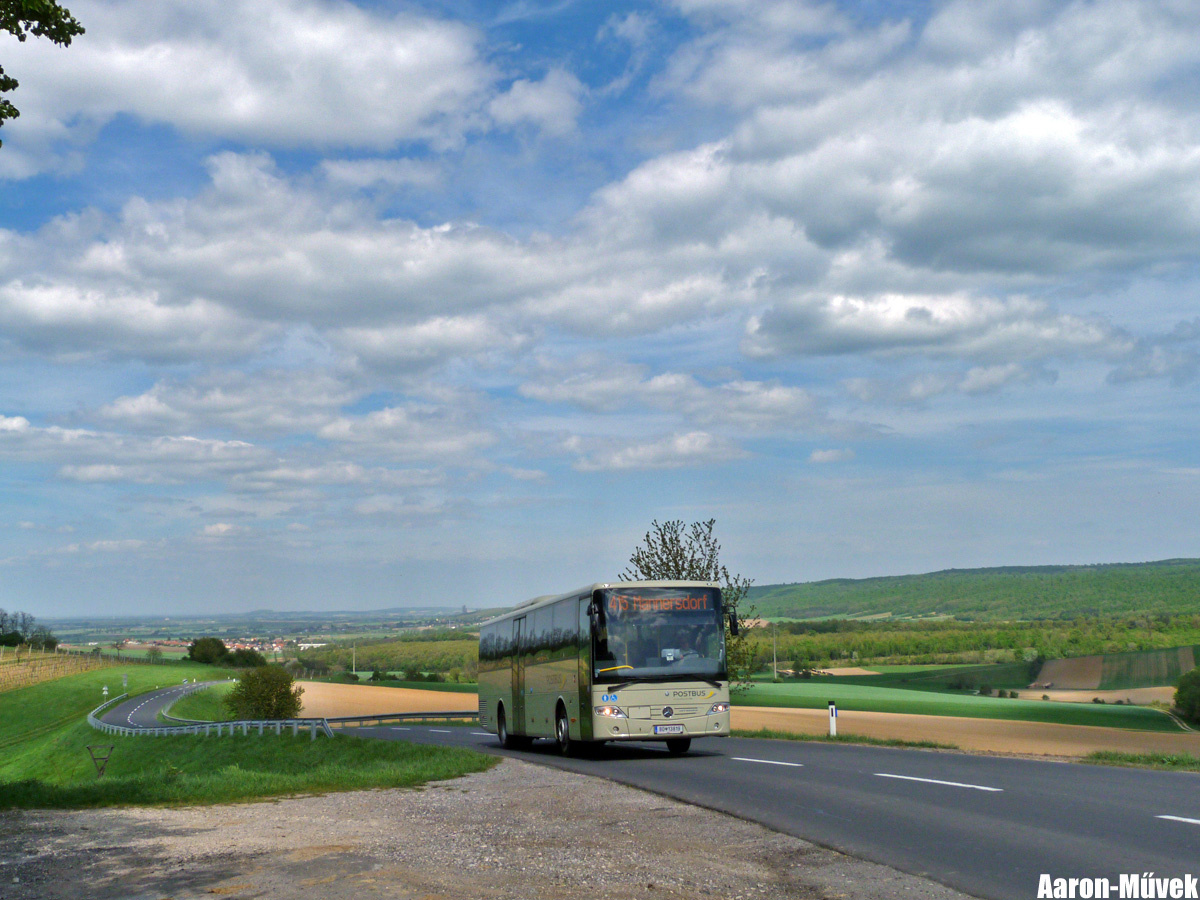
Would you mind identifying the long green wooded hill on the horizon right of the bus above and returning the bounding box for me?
[749,559,1200,620]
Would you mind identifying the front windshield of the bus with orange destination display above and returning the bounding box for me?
[593,588,726,683]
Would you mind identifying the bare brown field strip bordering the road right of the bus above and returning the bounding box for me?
[731,707,1200,756]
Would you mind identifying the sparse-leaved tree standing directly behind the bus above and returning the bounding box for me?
[620,518,756,688]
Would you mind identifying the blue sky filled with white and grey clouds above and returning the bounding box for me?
[0,0,1200,616]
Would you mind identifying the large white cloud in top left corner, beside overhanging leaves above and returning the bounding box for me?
[5,0,496,173]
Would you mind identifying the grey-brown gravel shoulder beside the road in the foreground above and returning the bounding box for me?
[0,760,965,900]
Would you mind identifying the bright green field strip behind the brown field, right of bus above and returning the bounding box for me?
[733,677,1181,731]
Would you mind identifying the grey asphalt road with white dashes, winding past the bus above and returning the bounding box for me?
[103,688,1200,900]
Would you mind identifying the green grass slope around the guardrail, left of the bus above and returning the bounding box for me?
[0,665,496,809]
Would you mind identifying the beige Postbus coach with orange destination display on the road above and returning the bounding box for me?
[479,581,738,755]
